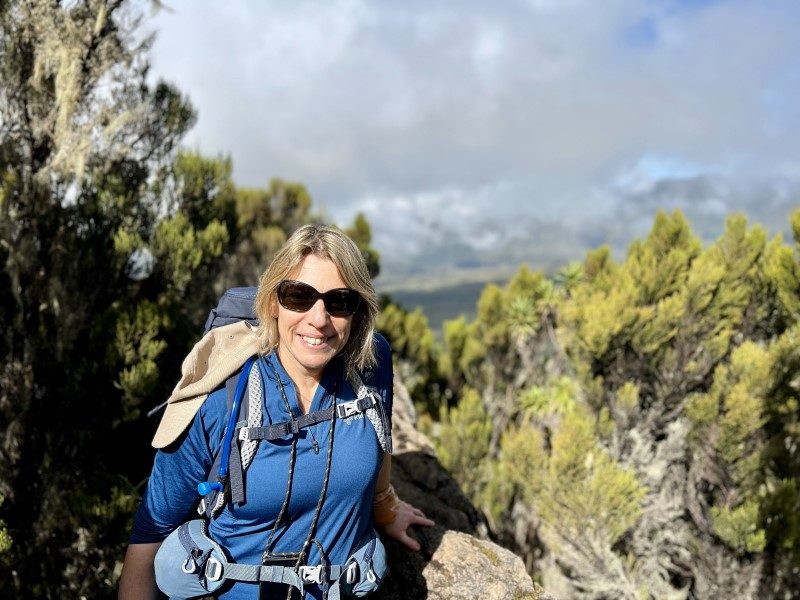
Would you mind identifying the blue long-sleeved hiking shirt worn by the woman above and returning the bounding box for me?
[130,335,392,600]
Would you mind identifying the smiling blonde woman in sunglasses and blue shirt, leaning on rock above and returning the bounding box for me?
[119,225,433,600]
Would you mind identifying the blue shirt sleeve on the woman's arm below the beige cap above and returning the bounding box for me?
[129,387,227,544]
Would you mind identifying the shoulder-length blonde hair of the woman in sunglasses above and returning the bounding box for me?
[255,225,379,375]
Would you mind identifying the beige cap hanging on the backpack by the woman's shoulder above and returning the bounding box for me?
[152,321,259,448]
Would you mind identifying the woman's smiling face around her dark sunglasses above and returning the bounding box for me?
[275,254,353,381]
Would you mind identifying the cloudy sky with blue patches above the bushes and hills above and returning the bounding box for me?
[147,0,800,287]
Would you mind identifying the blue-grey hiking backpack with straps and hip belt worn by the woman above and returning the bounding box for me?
[155,287,392,600]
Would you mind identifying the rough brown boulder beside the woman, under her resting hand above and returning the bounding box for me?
[374,378,553,600]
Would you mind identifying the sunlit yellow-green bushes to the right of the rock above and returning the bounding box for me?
[398,211,800,598]
